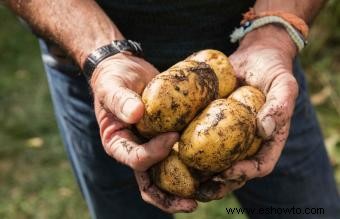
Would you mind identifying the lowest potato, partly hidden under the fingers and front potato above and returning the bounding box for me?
[151,143,199,198]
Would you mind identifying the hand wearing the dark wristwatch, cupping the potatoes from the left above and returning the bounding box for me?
[91,53,197,213]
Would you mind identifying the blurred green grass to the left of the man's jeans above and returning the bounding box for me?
[0,8,89,219]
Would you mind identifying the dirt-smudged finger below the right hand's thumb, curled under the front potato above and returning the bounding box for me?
[220,123,290,181]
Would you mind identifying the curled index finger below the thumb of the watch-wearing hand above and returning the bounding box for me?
[95,101,178,170]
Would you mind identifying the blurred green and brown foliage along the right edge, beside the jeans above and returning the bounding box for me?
[302,0,340,185]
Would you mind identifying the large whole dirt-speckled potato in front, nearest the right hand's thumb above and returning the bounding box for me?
[179,98,256,172]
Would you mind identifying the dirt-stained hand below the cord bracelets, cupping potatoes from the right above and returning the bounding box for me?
[198,26,298,201]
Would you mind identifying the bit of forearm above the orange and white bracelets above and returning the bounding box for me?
[254,0,327,23]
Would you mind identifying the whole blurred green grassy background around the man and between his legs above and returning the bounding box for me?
[0,0,340,219]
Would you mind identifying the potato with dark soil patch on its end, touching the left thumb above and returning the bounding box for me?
[136,60,218,137]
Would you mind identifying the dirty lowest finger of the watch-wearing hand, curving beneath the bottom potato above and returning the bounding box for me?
[135,171,197,213]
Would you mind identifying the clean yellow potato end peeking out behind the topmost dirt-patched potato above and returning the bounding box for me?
[187,49,237,98]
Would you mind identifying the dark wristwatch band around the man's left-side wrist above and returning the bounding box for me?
[83,40,143,80]
